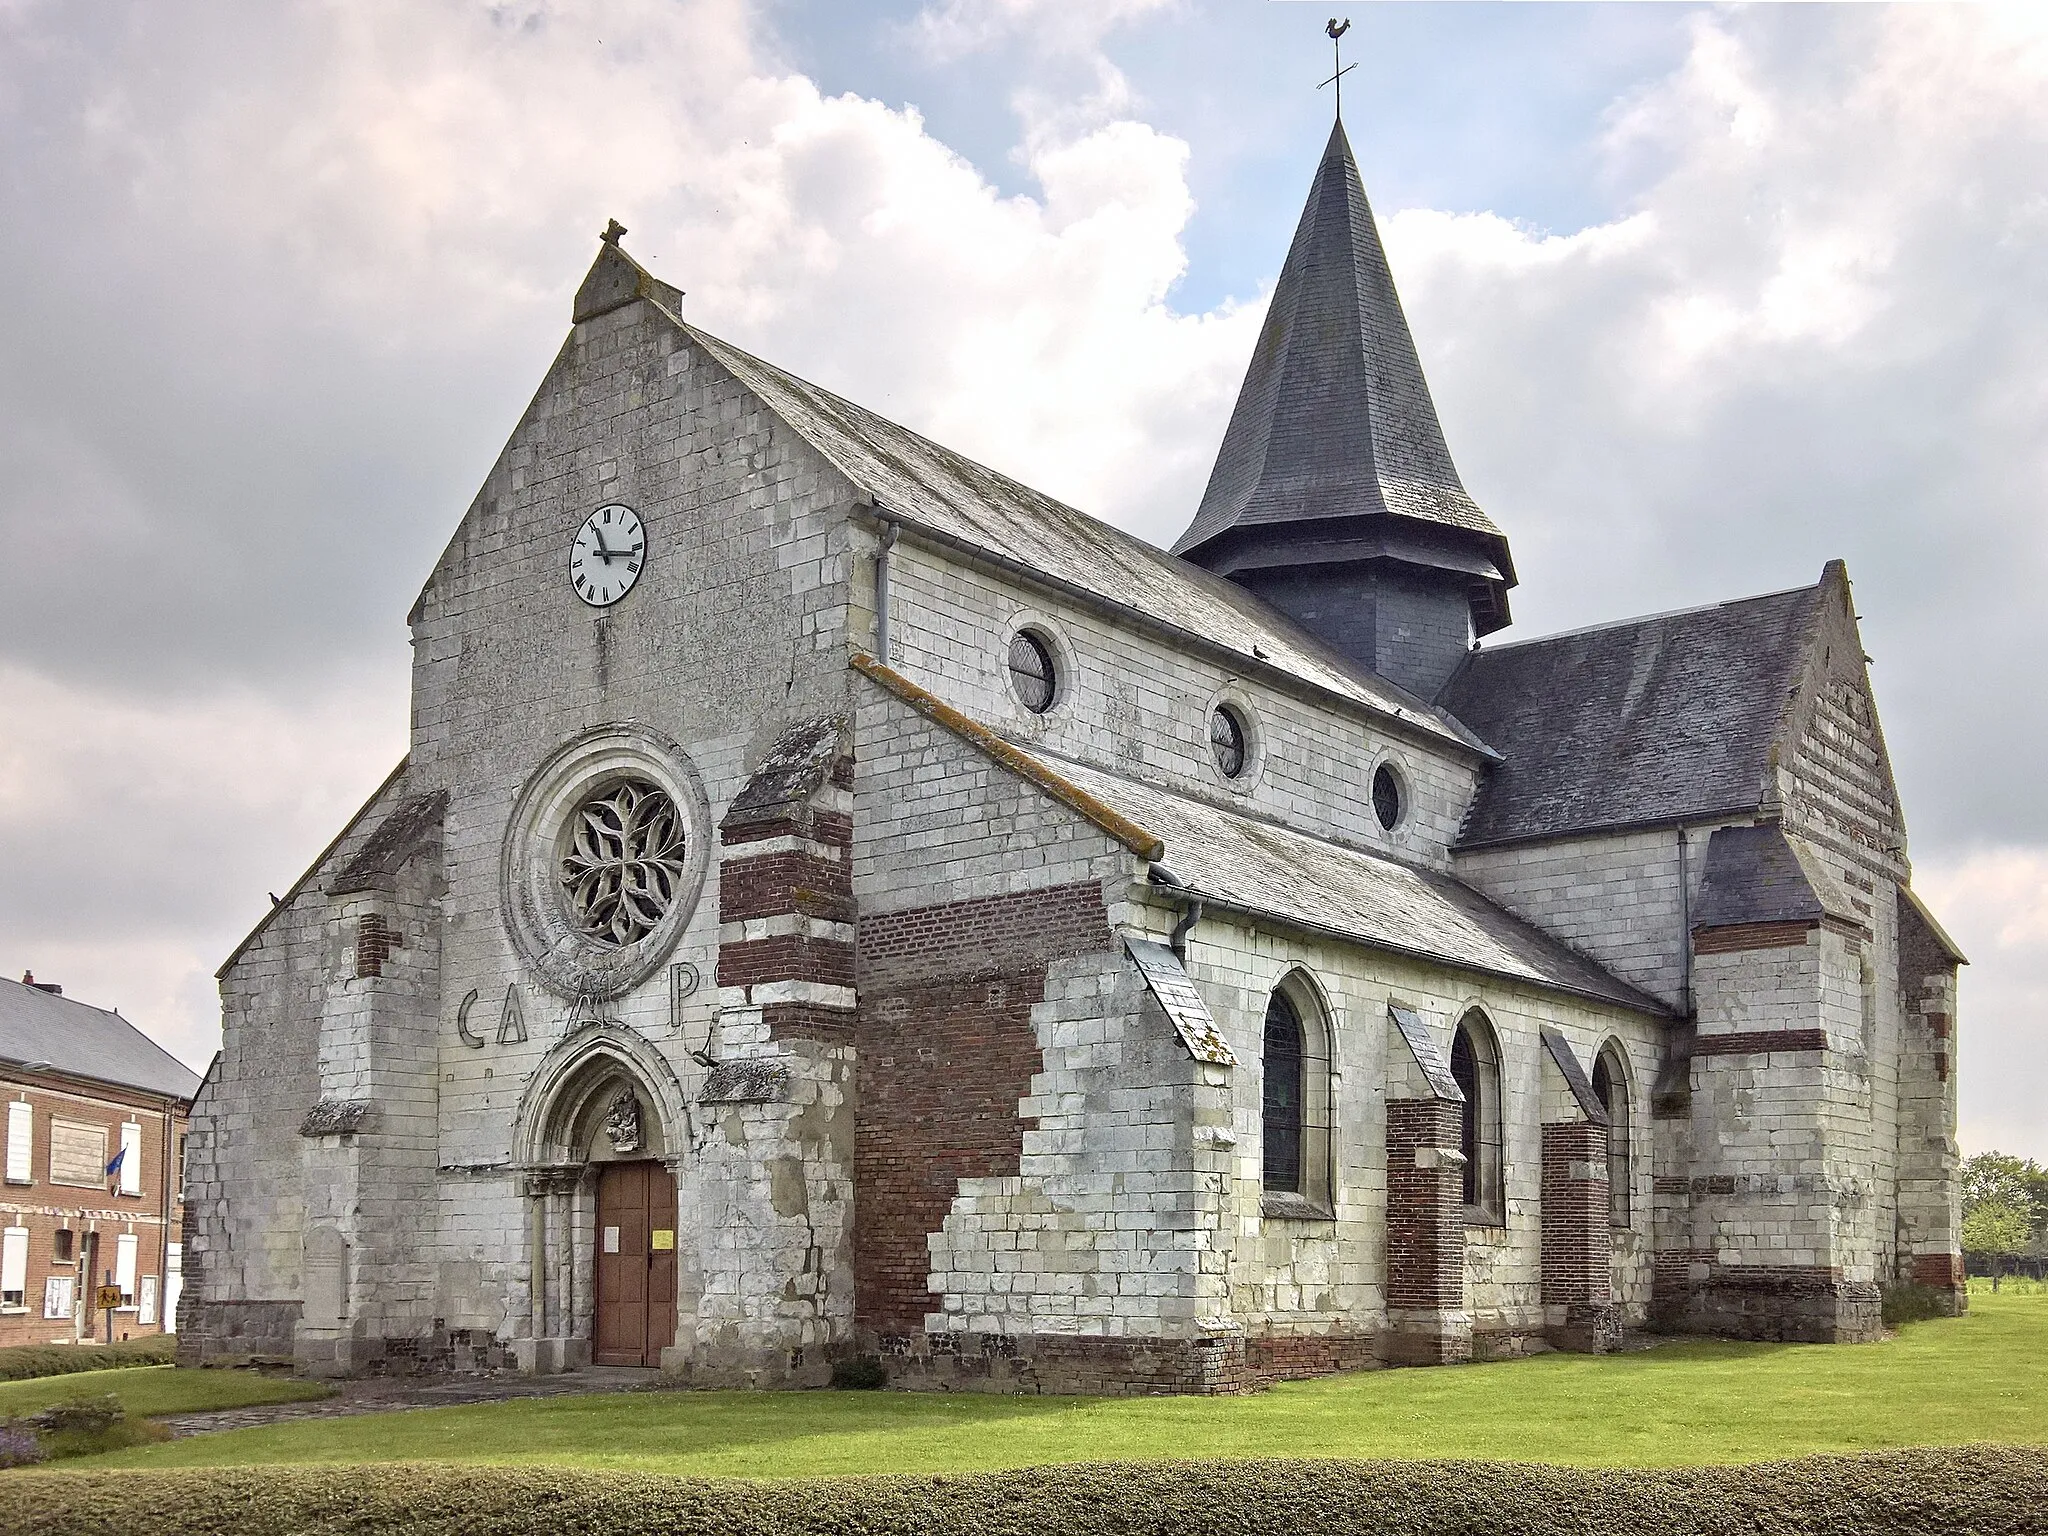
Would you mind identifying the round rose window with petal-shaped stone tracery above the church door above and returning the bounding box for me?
[561,778,686,948]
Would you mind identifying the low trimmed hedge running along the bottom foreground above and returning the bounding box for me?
[0,1446,2048,1536]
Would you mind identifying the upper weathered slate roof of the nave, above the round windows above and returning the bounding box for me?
[671,311,1487,754]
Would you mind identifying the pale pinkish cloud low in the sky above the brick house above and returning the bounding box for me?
[0,666,406,1069]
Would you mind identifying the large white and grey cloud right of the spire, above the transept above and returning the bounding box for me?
[1386,6,2048,846]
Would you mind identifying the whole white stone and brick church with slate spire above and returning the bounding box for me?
[180,125,1964,1393]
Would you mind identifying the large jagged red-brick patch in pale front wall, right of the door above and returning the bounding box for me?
[854,883,1112,1343]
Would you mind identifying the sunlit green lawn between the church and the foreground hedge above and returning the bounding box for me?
[76,1296,2048,1477]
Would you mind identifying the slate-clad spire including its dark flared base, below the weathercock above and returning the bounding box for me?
[1174,123,1516,694]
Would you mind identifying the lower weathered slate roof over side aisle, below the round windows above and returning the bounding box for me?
[1028,752,1669,1014]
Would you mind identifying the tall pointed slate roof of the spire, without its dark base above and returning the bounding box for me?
[1174,123,1507,581]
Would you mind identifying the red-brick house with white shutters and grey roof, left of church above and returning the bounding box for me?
[0,975,199,1346]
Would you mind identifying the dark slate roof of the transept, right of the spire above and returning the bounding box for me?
[1436,586,1821,848]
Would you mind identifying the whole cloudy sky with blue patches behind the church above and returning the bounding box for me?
[0,0,2048,1157]
